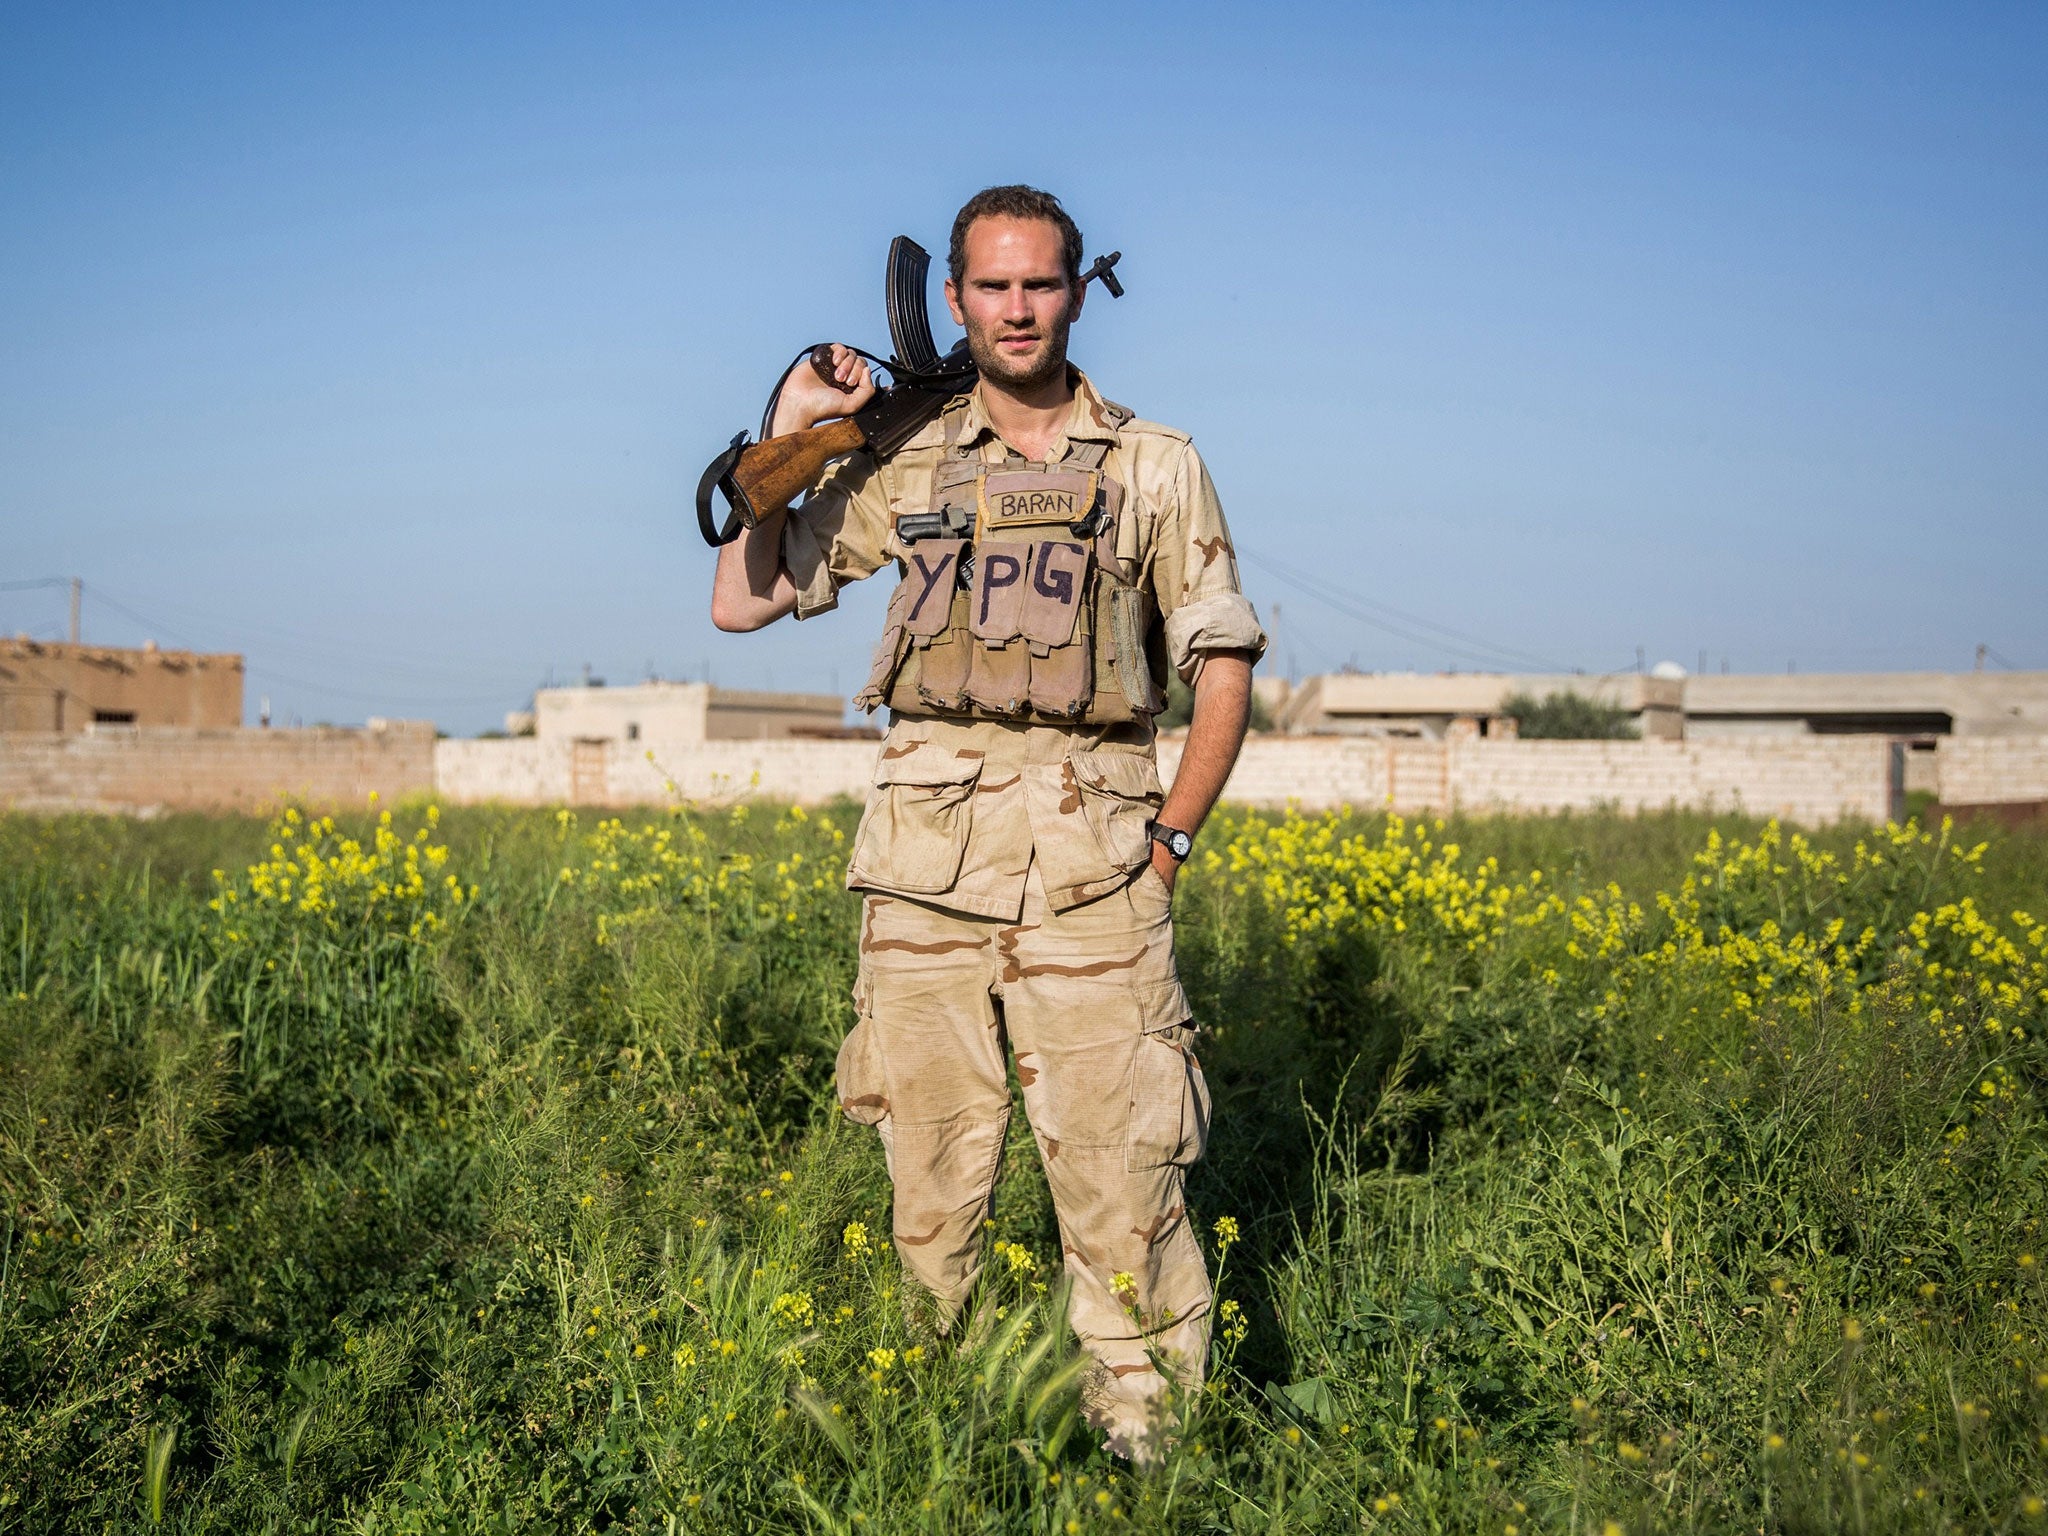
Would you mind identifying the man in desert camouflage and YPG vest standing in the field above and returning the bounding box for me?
[711,186,1266,1460]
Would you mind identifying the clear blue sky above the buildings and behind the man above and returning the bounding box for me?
[0,4,2048,733]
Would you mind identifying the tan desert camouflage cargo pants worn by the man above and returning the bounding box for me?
[838,866,1210,1456]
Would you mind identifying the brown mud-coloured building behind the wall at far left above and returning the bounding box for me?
[0,635,242,735]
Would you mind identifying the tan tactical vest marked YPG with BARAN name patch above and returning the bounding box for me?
[854,406,1165,725]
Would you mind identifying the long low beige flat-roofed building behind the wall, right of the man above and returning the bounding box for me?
[1276,664,2048,743]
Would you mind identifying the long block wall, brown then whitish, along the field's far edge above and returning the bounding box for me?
[0,721,2048,825]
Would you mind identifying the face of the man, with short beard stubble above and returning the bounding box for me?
[946,215,1083,391]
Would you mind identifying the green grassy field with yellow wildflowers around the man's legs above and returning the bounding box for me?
[0,807,2048,1536]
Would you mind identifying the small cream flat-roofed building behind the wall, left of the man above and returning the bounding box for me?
[524,682,848,745]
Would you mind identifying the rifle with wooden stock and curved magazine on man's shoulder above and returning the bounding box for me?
[696,236,1124,549]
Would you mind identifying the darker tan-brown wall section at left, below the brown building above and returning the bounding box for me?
[0,721,434,811]
